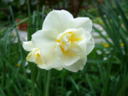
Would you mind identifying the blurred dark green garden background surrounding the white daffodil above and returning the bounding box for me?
[0,0,128,96]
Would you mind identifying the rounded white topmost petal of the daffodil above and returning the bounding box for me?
[42,10,73,34]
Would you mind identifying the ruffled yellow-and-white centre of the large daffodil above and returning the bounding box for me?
[56,31,83,53]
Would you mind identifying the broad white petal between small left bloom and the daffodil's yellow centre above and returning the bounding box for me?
[32,30,62,70]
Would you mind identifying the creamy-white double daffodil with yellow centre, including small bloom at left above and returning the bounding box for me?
[23,10,94,72]
